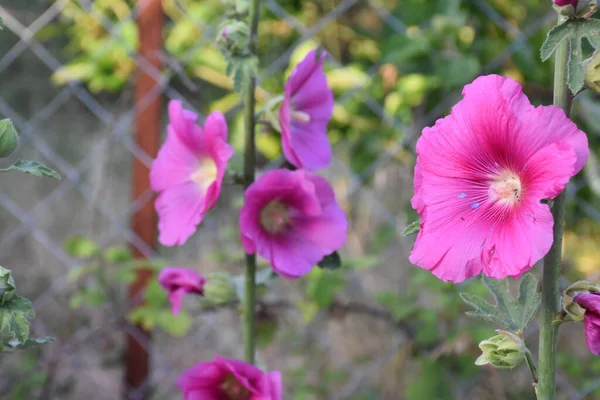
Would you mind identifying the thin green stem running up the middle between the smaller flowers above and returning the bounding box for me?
[244,0,260,364]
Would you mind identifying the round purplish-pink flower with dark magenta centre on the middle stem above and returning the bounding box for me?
[240,169,348,279]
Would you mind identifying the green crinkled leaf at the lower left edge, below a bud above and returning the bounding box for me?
[0,296,35,344]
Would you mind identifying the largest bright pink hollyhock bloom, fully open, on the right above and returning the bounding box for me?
[410,75,588,282]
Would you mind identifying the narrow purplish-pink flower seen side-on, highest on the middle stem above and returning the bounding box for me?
[279,50,333,170]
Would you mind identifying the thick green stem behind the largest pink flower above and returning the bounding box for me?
[537,15,570,400]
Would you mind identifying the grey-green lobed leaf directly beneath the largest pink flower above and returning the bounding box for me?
[461,274,542,332]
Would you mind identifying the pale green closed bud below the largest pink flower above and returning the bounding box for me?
[475,330,527,368]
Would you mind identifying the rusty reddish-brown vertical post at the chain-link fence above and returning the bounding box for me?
[124,0,164,400]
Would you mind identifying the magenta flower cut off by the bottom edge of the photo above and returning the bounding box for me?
[177,355,281,400]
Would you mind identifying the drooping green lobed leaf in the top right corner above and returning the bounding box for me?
[541,18,600,94]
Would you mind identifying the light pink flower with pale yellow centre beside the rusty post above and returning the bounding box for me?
[150,100,233,246]
